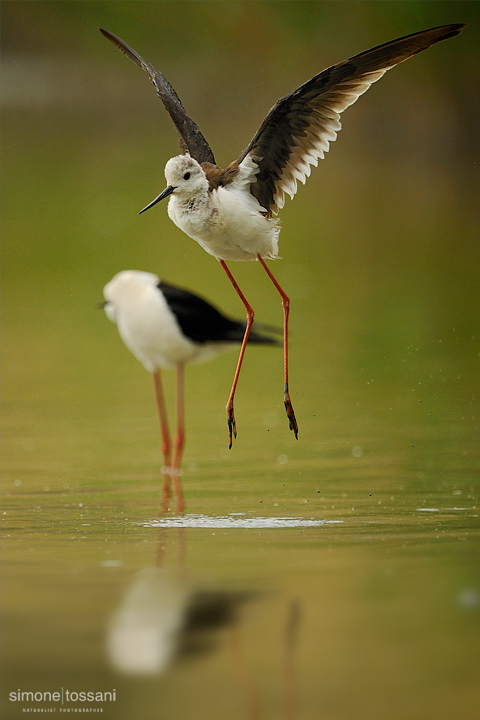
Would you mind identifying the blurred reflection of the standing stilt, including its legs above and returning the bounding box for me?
[107,528,254,674]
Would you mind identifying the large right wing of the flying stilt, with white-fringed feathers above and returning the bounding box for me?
[236,24,465,216]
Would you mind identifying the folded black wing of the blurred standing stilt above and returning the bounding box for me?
[158,282,277,345]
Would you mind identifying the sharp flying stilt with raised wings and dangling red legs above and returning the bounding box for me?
[100,23,465,447]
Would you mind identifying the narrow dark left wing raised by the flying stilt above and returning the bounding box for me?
[99,28,215,163]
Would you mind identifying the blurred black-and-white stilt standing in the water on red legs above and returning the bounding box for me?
[101,270,278,512]
